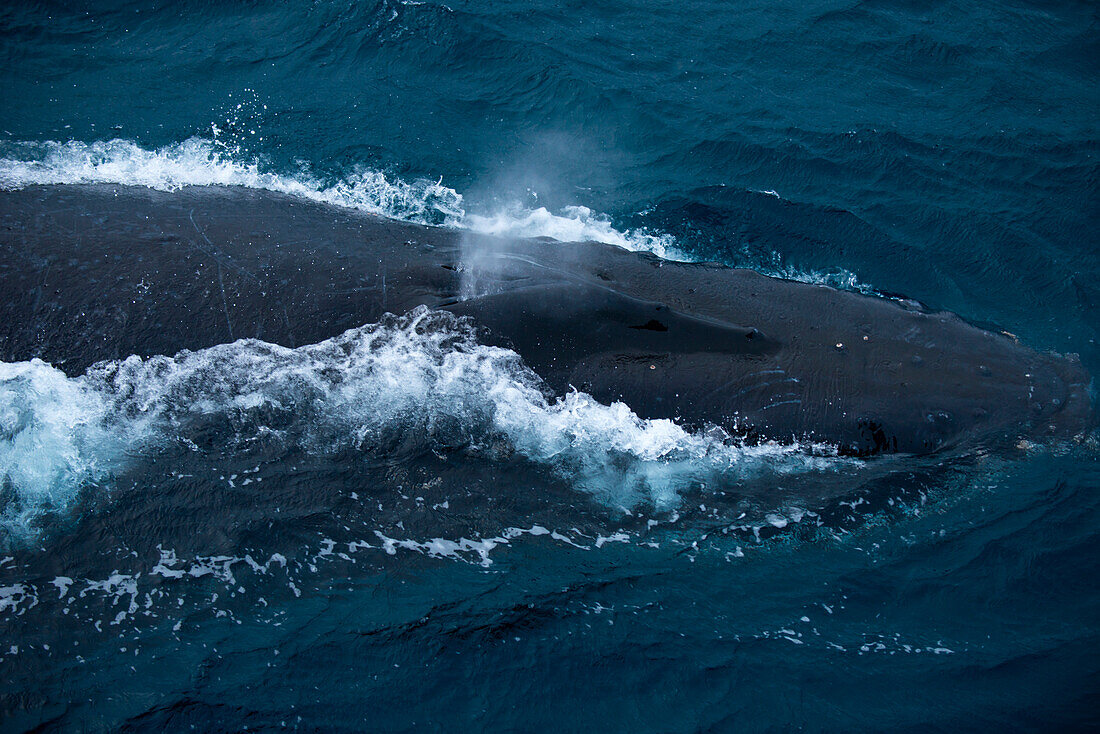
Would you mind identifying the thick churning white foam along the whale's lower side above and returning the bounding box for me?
[0,307,847,537]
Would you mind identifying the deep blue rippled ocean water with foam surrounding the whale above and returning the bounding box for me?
[0,0,1100,732]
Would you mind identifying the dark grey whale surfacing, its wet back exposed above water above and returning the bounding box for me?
[0,185,1095,456]
